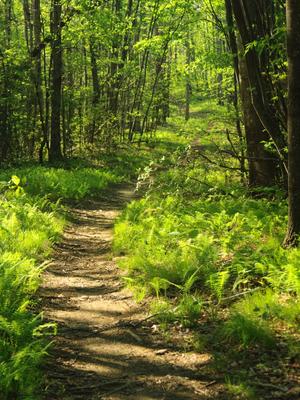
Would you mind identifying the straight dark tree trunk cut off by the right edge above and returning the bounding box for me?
[284,0,300,246]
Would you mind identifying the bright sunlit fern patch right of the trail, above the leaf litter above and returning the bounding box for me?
[114,191,292,298]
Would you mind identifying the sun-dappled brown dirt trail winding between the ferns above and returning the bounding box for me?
[40,186,219,400]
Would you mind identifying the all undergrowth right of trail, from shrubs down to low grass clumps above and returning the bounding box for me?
[114,101,300,374]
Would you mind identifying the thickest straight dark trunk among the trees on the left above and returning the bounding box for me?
[49,0,63,162]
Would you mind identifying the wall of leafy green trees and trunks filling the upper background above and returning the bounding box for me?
[1,0,287,167]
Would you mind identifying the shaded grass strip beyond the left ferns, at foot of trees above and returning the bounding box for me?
[0,129,186,202]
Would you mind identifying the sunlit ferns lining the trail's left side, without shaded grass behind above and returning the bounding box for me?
[0,180,64,399]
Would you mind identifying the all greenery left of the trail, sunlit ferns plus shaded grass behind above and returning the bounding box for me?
[0,154,149,399]
